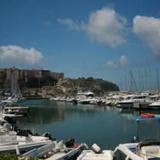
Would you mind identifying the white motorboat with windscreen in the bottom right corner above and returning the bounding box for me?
[114,141,160,160]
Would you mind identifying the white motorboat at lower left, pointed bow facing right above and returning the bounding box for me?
[0,128,51,155]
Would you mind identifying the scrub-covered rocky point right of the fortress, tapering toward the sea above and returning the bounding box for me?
[44,77,119,96]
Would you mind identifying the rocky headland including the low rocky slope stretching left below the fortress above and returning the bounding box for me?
[22,77,119,96]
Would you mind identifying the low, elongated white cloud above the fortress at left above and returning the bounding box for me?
[0,45,43,65]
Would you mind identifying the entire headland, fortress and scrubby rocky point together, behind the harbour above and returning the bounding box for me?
[0,67,119,97]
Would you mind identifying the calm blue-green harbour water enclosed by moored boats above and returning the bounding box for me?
[17,100,160,149]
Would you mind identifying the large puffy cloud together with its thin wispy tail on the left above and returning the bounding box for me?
[58,7,127,47]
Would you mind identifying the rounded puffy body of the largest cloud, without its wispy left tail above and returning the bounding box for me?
[86,8,126,47]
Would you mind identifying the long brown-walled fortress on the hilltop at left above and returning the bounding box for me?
[0,67,64,89]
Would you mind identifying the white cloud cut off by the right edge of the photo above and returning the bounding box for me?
[133,16,160,55]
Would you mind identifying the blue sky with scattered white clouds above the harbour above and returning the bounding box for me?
[0,0,160,89]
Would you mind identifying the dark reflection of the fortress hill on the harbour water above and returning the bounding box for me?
[19,100,99,125]
